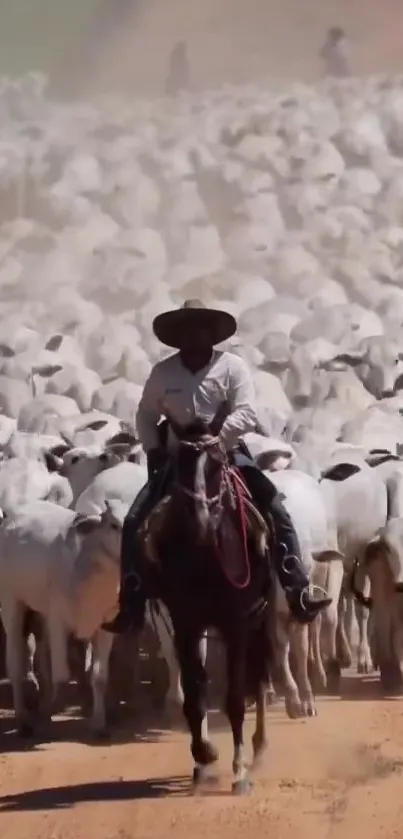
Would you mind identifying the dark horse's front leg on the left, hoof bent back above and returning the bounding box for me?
[175,627,218,783]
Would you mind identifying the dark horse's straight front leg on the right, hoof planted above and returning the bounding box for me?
[225,633,250,795]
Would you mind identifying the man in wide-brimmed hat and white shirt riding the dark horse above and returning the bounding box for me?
[103,300,331,633]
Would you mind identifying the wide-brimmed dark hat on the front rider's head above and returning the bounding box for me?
[153,300,237,349]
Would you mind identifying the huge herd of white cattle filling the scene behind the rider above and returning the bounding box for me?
[0,69,403,744]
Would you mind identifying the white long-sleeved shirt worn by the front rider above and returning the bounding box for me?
[136,350,256,452]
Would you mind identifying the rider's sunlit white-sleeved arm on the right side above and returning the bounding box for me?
[220,353,257,451]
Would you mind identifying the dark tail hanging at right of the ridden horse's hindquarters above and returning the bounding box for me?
[245,605,274,699]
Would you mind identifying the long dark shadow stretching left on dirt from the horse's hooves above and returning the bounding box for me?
[0,775,190,813]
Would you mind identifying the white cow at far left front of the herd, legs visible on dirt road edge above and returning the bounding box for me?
[0,501,122,733]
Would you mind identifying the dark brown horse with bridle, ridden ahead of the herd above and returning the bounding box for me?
[129,423,274,793]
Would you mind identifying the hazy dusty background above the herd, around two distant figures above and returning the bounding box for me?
[0,0,403,92]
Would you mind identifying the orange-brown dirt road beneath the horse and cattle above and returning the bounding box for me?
[0,680,403,839]
